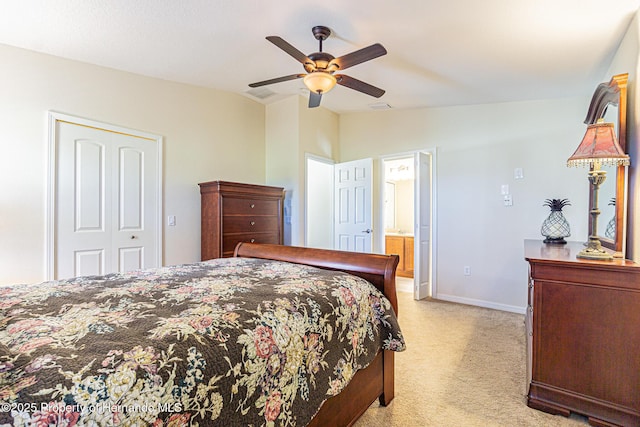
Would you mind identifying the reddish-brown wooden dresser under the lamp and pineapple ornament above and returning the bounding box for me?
[525,240,640,426]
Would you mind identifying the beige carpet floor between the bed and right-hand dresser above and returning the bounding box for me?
[355,292,587,427]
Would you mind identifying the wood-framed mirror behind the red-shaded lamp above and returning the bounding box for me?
[584,74,629,257]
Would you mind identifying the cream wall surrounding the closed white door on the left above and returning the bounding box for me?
[0,45,265,284]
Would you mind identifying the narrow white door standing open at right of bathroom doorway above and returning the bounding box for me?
[413,152,432,299]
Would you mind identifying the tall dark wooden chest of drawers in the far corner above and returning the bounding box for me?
[198,181,284,261]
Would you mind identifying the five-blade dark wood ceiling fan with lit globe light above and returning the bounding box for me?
[249,25,387,108]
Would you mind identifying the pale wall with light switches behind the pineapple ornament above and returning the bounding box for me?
[340,98,591,311]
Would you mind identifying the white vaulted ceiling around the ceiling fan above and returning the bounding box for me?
[0,0,640,113]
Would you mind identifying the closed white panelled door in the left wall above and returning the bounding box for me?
[52,115,161,279]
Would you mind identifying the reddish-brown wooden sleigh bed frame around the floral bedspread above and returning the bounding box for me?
[234,243,399,426]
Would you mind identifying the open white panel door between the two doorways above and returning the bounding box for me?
[334,159,373,252]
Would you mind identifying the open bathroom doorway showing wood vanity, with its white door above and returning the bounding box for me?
[380,152,435,299]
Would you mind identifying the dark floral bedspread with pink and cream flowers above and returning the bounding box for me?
[0,258,405,427]
